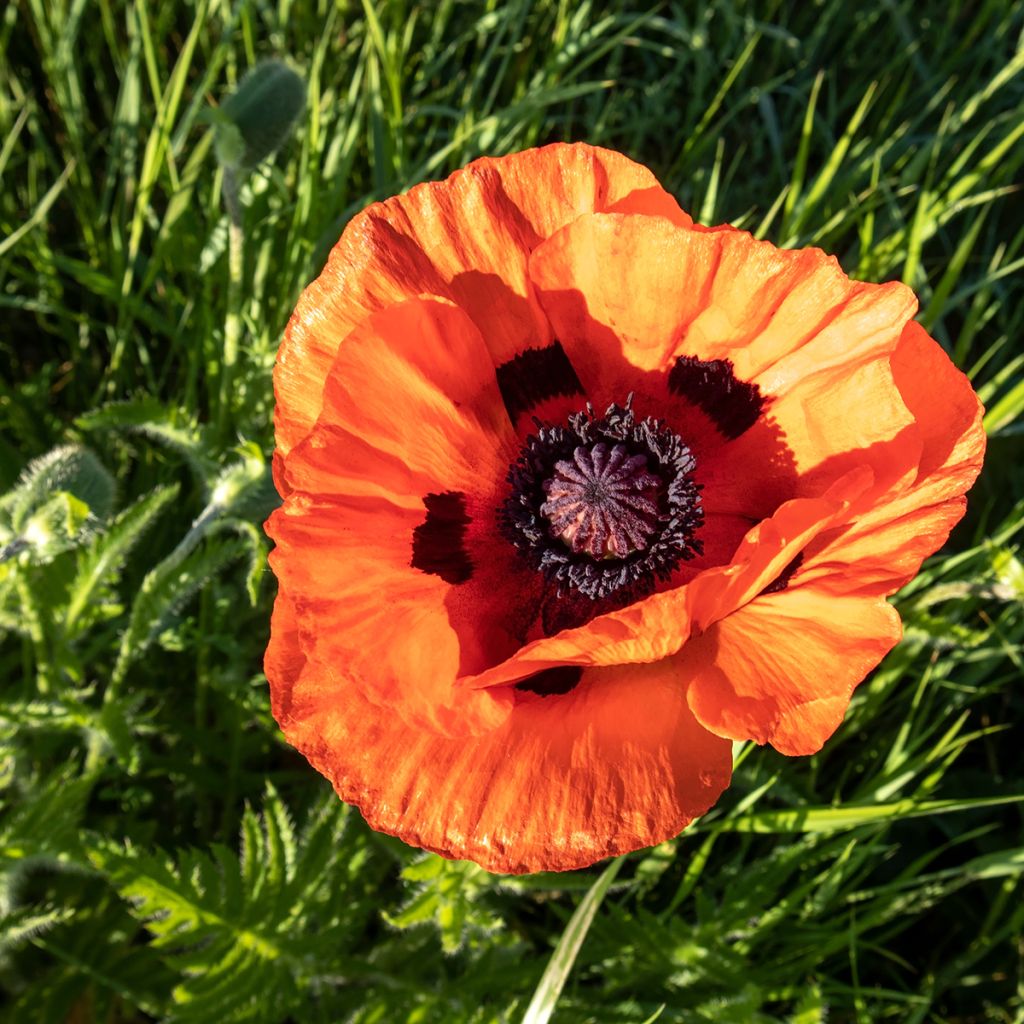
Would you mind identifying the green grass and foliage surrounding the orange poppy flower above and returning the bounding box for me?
[0,0,1024,1024]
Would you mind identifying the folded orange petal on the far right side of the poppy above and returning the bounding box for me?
[680,323,985,754]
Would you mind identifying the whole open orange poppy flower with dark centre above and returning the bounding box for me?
[266,145,984,871]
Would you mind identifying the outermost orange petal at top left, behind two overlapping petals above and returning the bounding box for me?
[274,144,685,452]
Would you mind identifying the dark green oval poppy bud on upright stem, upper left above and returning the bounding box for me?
[218,60,306,170]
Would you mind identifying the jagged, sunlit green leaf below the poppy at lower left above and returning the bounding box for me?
[88,790,367,1024]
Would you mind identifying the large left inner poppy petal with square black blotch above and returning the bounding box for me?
[267,298,521,732]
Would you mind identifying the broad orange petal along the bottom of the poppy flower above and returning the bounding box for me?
[265,592,731,872]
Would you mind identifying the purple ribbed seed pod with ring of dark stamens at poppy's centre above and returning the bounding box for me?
[499,396,703,601]
